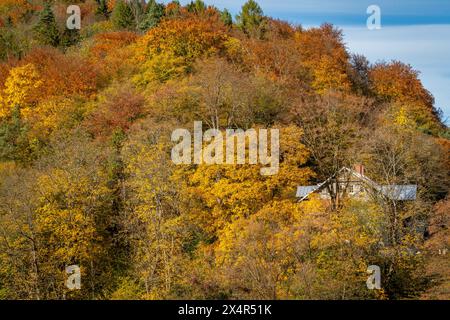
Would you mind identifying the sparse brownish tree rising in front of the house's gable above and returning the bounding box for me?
[291,94,373,209]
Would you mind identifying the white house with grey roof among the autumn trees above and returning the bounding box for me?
[297,165,417,201]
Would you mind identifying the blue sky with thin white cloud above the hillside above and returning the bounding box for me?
[164,0,450,124]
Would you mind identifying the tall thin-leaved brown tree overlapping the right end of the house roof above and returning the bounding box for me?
[362,124,448,299]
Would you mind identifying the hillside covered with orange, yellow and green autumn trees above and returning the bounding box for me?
[0,0,450,299]
